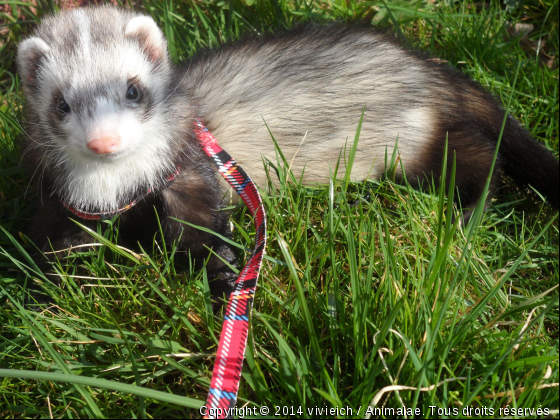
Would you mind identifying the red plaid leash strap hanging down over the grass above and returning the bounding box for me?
[195,119,266,418]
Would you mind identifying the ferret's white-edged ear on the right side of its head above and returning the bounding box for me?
[124,16,167,63]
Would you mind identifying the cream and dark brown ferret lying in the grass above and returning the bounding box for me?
[17,6,559,295]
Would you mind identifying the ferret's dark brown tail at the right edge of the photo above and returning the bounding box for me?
[500,116,560,209]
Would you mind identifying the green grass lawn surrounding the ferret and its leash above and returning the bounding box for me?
[0,0,560,418]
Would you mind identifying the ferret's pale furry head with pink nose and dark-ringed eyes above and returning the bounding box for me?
[17,7,180,211]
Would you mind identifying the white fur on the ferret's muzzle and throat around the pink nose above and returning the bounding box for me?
[54,91,173,211]
